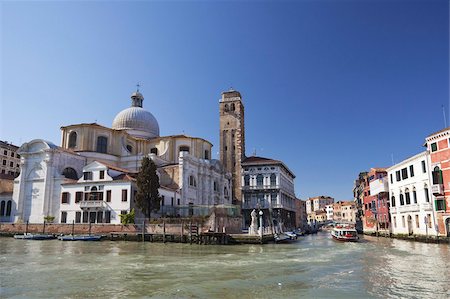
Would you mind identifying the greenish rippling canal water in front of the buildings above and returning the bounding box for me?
[0,233,450,298]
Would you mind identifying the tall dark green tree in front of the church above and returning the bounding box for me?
[135,157,161,219]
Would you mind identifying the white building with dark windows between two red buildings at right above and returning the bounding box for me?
[383,151,436,236]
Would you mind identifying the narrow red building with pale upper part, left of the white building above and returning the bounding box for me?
[363,168,390,233]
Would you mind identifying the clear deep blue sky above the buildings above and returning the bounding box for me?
[0,0,450,200]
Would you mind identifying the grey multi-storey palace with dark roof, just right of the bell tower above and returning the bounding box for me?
[241,156,298,230]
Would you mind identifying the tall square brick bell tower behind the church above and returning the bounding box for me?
[219,89,245,205]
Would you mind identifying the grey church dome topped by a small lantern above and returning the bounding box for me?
[112,91,159,138]
